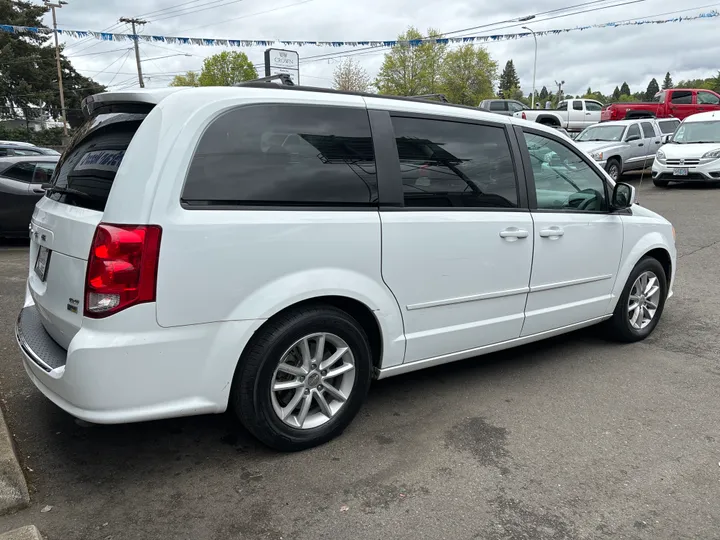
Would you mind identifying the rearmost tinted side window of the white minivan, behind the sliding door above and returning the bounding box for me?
[182,105,378,206]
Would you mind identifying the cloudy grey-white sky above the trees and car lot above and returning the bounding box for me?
[38,0,720,98]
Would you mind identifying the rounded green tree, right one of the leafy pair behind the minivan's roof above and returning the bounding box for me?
[440,44,498,107]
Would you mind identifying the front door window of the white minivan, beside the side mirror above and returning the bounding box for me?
[525,133,607,212]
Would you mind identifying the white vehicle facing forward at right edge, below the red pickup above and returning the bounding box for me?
[652,111,720,187]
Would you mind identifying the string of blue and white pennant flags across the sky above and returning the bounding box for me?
[0,10,720,47]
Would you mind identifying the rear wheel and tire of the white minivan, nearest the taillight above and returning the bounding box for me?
[231,306,372,452]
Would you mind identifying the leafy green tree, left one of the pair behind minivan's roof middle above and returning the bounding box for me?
[375,26,447,96]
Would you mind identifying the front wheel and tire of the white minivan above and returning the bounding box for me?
[606,257,667,343]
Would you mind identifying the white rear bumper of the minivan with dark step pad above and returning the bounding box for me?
[15,298,259,424]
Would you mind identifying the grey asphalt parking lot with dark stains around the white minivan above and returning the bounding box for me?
[0,180,720,540]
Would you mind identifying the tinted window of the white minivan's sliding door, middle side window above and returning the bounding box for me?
[392,117,518,208]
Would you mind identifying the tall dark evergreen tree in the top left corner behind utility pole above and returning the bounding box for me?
[0,0,105,127]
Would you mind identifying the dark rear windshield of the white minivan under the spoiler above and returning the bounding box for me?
[47,113,146,212]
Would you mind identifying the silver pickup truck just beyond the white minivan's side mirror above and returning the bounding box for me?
[575,118,663,181]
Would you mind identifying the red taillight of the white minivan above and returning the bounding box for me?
[84,223,162,319]
